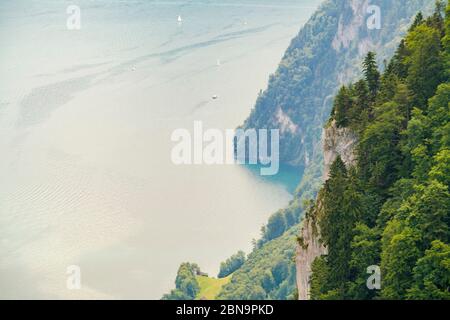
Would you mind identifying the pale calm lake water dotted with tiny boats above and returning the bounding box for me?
[0,0,320,299]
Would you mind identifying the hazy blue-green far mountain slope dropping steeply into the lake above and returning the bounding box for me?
[243,0,434,170]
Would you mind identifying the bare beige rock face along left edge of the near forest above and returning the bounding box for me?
[296,121,358,300]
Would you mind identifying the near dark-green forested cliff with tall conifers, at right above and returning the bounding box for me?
[297,2,450,299]
